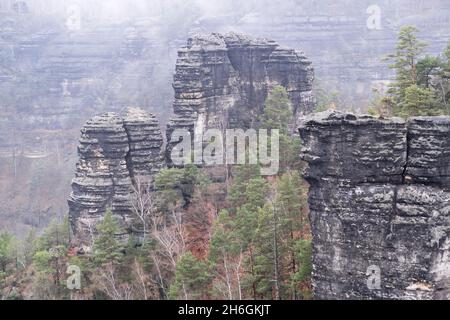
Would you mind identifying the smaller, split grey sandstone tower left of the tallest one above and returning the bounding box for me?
[69,108,164,243]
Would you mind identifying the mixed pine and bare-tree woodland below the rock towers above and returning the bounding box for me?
[0,87,311,299]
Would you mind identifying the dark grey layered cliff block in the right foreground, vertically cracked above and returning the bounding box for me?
[300,112,450,299]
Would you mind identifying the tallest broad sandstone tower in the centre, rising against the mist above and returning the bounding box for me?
[167,33,315,160]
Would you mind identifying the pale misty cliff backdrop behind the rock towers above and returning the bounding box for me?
[0,0,450,234]
